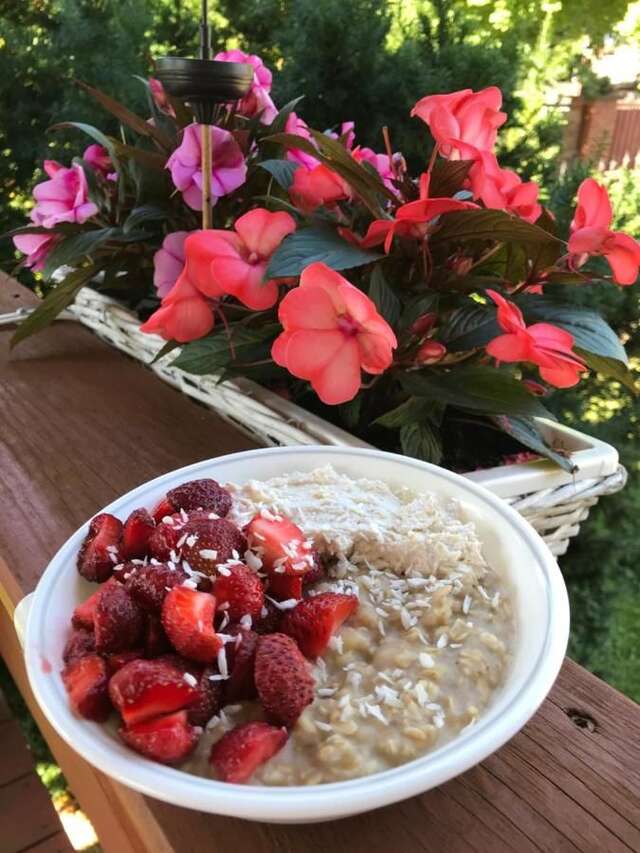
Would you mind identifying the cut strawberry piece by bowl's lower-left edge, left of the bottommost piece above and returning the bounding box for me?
[118,711,200,764]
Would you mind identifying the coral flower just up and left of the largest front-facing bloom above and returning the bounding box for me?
[179,208,296,311]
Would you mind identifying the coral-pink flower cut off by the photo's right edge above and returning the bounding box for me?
[569,178,640,285]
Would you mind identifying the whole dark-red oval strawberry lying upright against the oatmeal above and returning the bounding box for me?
[255,634,315,728]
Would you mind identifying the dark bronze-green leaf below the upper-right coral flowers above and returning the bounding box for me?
[431,208,562,246]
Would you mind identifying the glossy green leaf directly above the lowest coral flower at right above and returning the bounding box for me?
[514,295,628,364]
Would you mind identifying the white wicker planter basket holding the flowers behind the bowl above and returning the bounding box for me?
[7,288,627,555]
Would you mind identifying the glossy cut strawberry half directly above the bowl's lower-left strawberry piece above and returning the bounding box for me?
[109,660,199,726]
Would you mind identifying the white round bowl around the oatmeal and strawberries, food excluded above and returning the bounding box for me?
[25,447,569,823]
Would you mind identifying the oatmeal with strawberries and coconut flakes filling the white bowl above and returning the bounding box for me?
[63,467,515,785]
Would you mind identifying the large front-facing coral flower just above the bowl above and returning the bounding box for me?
[271,263,398,405]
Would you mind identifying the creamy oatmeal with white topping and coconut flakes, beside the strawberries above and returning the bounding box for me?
[185,467,514,785]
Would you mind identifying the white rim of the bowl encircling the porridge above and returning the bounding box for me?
[25,445,569,823]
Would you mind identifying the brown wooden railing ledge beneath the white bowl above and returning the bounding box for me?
[0,280,640,853]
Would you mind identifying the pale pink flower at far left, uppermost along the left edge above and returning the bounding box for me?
[31,160,98,228]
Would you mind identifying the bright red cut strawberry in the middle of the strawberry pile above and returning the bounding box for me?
[162,586,222,663]
